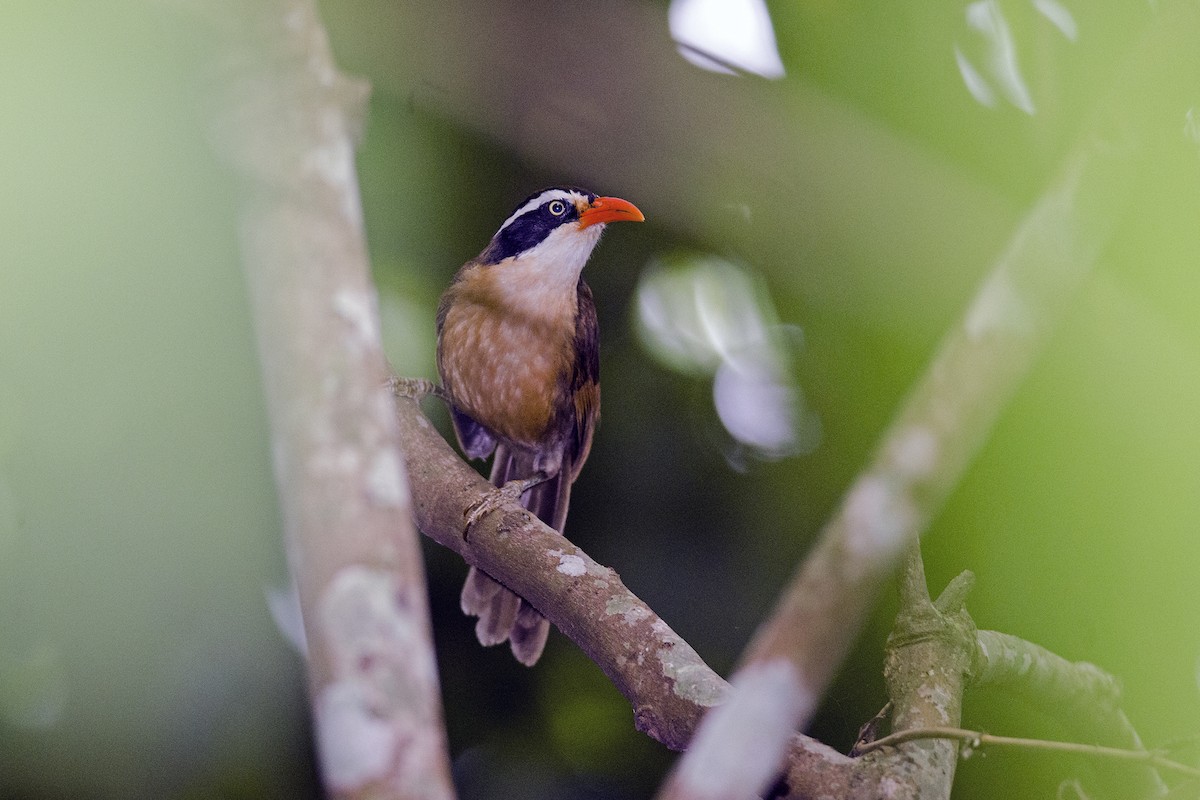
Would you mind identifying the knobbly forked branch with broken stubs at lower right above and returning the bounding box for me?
[854,547,1166,800]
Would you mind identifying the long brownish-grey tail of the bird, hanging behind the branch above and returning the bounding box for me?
[462,444,571,667]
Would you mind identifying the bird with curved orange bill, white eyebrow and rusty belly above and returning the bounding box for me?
[437,186,646,667]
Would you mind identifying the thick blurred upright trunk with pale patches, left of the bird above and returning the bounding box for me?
[206,0,454,800]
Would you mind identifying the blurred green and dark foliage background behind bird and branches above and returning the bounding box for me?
[7,0,1200,799]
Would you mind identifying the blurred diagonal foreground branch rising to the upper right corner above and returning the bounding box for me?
[660,4,1198,799]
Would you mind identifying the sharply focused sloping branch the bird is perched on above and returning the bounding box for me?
[396,380,852,793]
